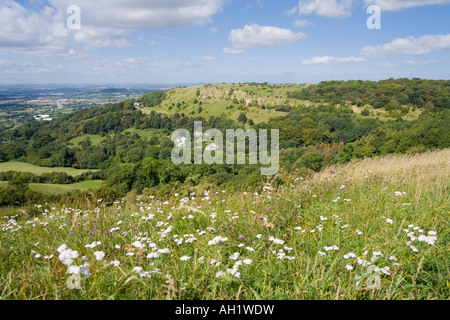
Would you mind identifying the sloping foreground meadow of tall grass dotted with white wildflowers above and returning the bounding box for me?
[0,149,450,300]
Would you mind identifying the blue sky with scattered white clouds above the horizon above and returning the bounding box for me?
[0,0,450,85]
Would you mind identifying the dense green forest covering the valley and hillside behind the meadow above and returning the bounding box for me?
[0,79,450,202]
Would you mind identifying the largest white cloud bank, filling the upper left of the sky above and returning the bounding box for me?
[0,0,225,57]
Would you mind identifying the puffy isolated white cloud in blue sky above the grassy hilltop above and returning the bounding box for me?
[224,24,305,53]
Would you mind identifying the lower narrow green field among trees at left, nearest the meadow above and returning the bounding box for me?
[0,180,104,195]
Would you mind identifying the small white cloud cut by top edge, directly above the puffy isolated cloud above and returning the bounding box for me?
[298,0,355,18]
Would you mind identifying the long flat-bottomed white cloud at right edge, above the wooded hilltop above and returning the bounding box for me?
[361,34,450,56]
